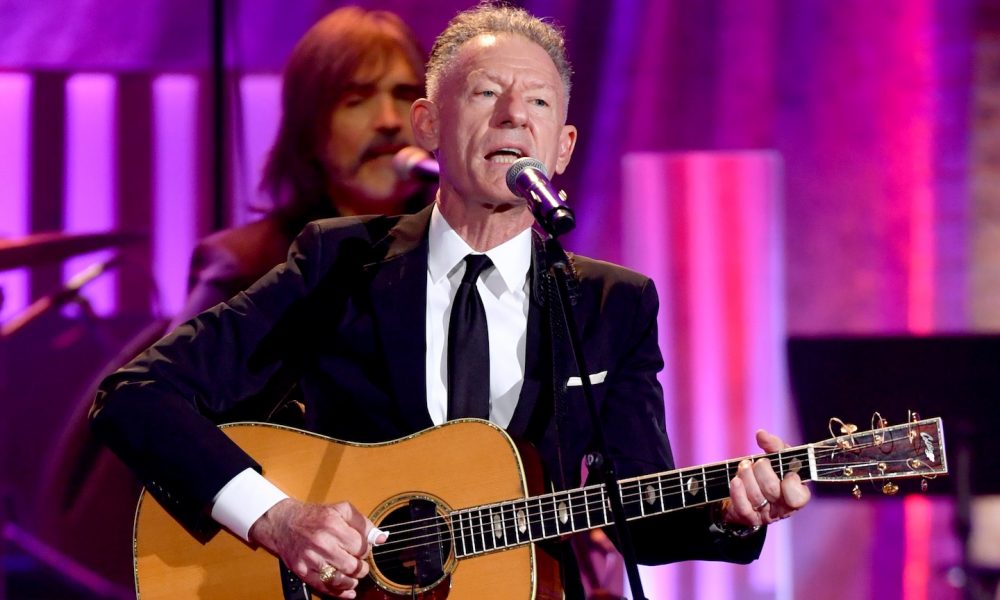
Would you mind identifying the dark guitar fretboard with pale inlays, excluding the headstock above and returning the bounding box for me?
[449,446,814,558]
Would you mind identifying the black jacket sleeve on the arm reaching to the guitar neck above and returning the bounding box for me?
[588,278,764,564]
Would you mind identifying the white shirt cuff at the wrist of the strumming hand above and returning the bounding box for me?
[212,469,288,541]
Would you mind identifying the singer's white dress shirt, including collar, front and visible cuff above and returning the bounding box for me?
[212,205,531,540]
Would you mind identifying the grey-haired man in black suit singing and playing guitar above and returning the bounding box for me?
[93,5,809,598]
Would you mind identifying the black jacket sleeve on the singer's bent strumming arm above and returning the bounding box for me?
[91,220,364,531]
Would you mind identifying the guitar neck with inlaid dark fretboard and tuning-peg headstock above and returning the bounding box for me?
[449,419,947,558]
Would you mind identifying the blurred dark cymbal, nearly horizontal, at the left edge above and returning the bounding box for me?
[0,231,147,271]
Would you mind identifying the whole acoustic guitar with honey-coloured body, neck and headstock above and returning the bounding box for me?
[134,415,948,600]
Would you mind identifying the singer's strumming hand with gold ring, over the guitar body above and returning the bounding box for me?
[250,498,384,598]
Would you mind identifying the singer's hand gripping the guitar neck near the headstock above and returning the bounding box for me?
[722,429,810,527]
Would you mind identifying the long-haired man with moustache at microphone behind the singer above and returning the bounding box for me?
[174,6,430,325]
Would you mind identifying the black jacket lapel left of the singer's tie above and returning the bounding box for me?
[365,207,433,431]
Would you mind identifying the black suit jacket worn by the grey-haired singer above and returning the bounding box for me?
[92,208,763,576]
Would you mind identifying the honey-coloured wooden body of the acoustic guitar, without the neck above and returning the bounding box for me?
[135,420,559,600]
